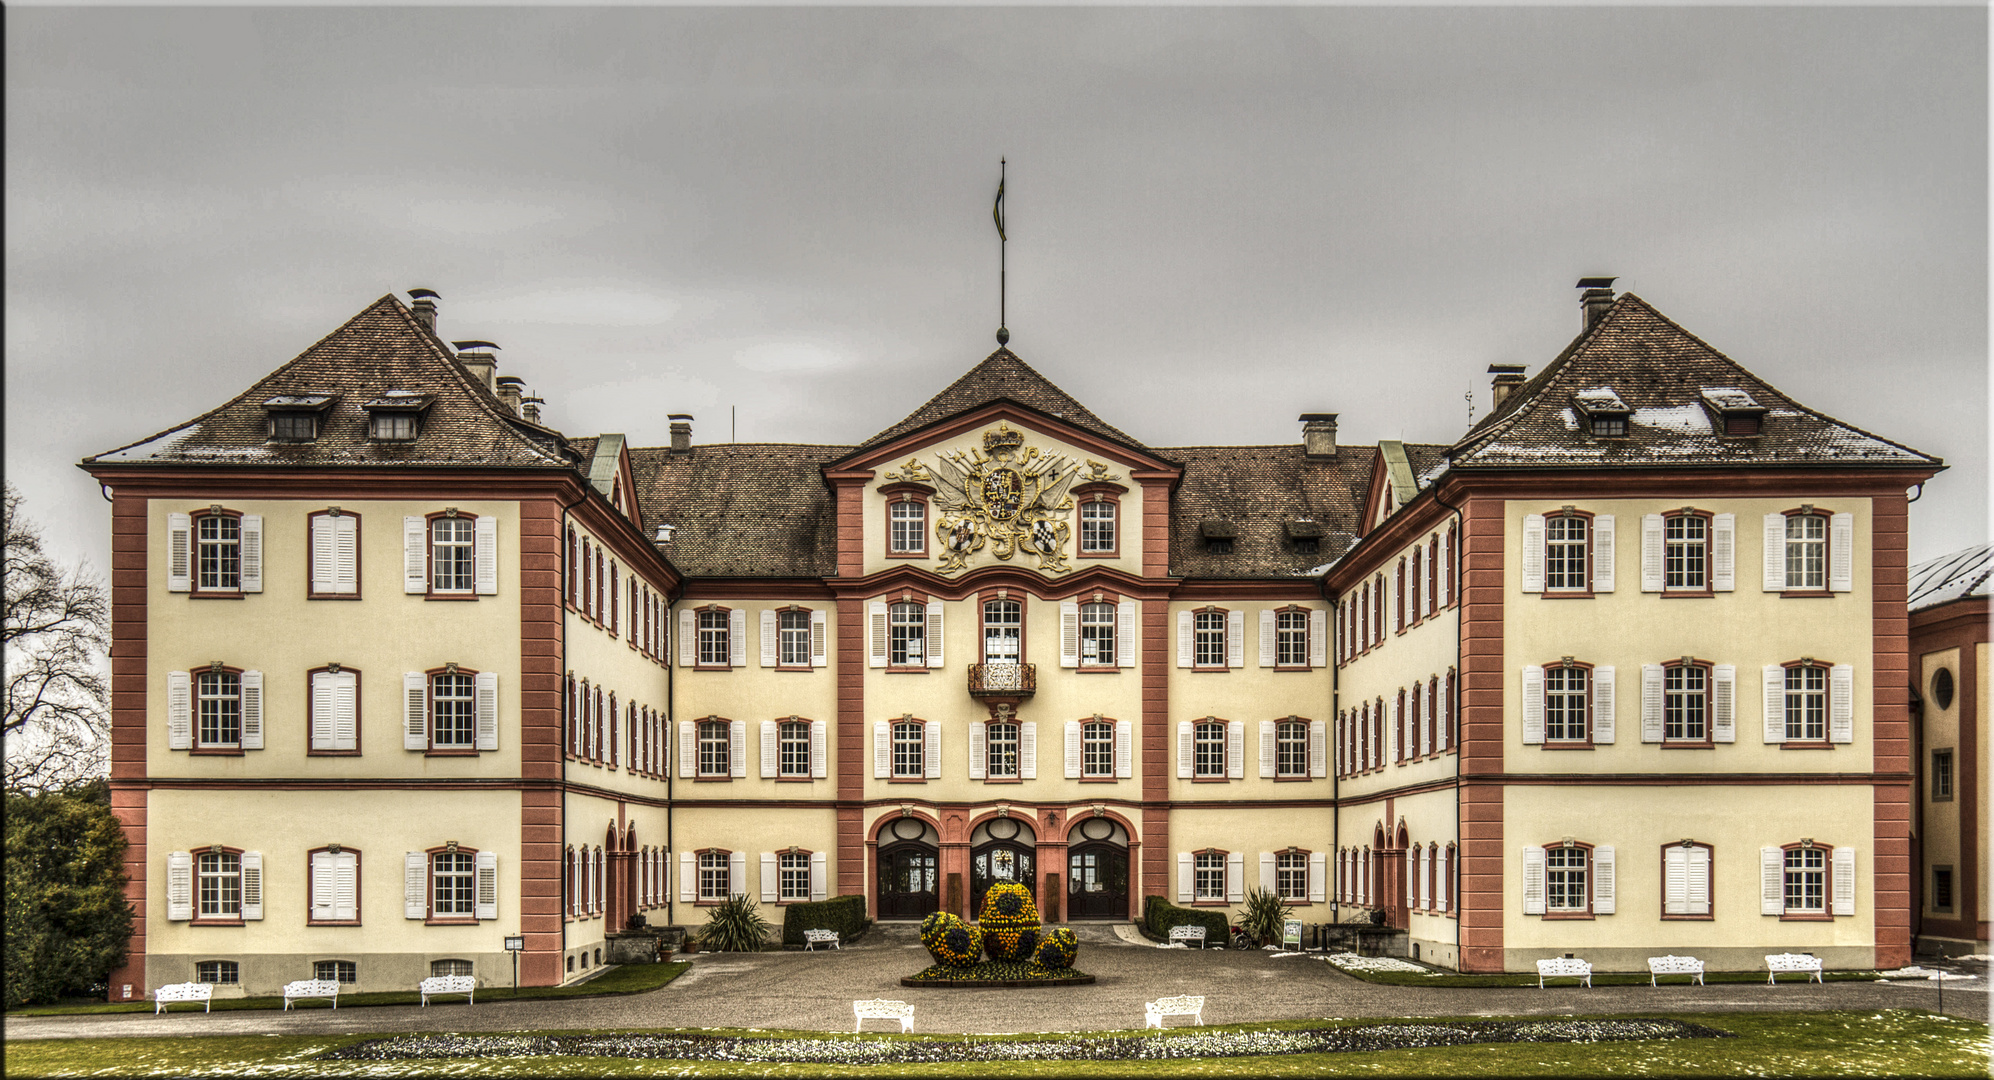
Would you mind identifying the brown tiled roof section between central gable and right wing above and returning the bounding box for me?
[1157,444,1378,578]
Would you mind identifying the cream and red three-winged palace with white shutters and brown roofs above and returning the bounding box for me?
[82,279,1946,998]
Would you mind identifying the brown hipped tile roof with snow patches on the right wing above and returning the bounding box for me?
[1448,293,1942,468]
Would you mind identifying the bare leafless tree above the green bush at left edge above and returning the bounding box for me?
[0,484,110,791]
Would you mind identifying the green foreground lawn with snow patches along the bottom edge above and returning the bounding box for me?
[6,1010,1990,1078]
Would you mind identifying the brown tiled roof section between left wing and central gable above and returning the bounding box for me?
[630,442,855,578]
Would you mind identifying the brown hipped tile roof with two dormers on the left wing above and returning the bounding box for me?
[86,295,572,468]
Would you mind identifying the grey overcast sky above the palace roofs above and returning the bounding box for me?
[6,6,1988,581]
